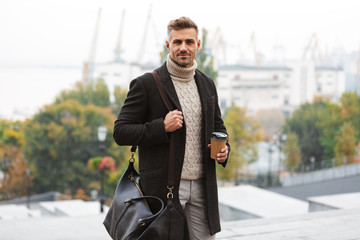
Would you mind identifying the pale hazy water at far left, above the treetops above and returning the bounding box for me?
[0,67,82,120]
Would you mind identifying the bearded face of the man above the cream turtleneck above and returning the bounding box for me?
[166,28,200,67]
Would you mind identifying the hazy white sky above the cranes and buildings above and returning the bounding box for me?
[0,0,360,67]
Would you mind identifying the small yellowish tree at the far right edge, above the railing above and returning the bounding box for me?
[334,122,356,165]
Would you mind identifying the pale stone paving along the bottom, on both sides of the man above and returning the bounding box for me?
[0,208,360,240]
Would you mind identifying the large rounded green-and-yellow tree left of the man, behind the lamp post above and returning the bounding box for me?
[24,100,119,193]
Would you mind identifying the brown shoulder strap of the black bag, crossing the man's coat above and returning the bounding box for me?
[151,71,175,195]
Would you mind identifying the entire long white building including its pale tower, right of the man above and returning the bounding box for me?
[217,60,345,116]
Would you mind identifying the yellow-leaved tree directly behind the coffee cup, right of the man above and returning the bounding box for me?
[217,106,260,180]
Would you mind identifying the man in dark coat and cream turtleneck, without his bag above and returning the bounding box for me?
[114,17,230,240]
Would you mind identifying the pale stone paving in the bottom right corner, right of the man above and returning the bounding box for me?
[216,208,360,240]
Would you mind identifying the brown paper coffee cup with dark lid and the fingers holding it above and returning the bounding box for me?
[211,132,228,163]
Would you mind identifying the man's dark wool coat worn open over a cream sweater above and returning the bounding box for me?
[113,64,226,234]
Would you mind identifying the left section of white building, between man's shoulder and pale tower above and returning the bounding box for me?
[217,65,292,114]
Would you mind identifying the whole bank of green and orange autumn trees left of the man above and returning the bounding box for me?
[0,79,130,199]
